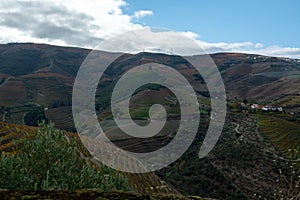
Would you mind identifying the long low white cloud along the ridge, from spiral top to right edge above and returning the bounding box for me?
[95,28,300,58]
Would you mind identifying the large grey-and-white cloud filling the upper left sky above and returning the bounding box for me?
[0,0,142,48]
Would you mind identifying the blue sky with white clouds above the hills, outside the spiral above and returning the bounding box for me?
[0,0,300,59]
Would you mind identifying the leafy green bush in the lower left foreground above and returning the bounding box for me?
[0,124,131,191]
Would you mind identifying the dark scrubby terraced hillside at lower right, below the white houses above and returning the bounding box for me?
[159,113,300,199]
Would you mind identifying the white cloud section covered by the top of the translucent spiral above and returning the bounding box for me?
[98,28,205,55]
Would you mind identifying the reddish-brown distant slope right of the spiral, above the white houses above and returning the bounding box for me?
[212,54,300,102]
